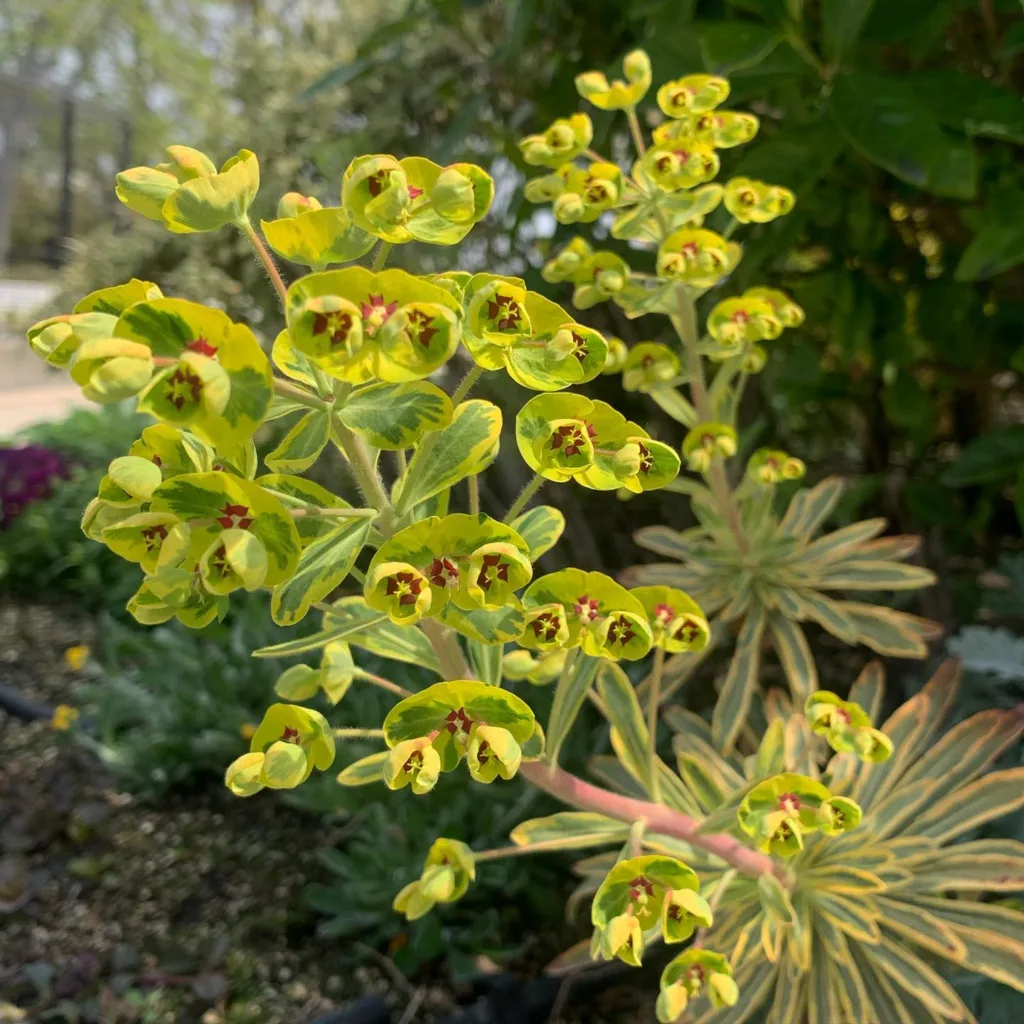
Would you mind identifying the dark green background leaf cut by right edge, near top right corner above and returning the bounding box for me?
[907,68,1024,142]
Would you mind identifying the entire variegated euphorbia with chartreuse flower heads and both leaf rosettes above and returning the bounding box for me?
[29,50,1024,1024]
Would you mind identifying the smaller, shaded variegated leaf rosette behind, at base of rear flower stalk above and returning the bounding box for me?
[622,477,941,751]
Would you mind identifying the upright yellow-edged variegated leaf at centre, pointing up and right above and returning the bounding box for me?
[395,399,502,515]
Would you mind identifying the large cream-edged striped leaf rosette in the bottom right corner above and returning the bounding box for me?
[670,663,1024,1024]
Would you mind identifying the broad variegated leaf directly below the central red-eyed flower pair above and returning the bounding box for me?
[338,381,453,452]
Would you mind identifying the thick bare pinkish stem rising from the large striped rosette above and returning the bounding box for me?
[519,761,778,877]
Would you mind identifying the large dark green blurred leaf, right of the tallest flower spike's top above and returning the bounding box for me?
[829,72,977,199]
